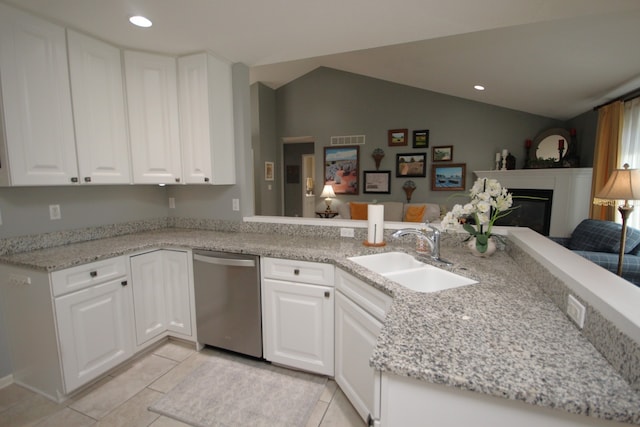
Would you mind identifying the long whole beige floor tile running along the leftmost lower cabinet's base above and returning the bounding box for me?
[70,354,176,420]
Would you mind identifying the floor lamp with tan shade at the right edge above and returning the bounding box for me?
[593,163,640,277]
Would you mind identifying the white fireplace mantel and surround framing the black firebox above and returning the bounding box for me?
[474,168,593,237]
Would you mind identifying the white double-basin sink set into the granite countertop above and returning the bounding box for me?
[349,252,478,292]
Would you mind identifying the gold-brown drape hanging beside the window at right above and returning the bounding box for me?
[589,101,624,221]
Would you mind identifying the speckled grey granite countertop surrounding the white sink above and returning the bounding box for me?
[0,229,640,424]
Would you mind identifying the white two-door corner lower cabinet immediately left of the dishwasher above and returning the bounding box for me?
[130,249,193,345]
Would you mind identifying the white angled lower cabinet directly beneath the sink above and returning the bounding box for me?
[335,269,391,425]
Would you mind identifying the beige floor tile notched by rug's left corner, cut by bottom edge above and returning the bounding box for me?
[96,388,163,427]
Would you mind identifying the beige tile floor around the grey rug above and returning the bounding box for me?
[0,340,365,427]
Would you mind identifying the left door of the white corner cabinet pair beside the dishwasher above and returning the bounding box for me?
[131,251,167,345]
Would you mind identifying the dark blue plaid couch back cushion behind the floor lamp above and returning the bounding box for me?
[569,219,640,253]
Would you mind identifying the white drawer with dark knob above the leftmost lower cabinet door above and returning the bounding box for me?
[51,257,127,296]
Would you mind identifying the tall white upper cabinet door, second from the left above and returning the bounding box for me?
[67,30,131,184]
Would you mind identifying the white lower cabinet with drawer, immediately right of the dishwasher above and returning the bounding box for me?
[261,258,334,376]
